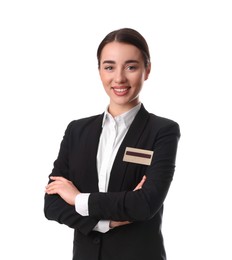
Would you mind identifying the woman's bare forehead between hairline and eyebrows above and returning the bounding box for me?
[101,42,142,62]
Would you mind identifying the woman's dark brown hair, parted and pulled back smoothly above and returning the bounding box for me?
[97,28,150,68]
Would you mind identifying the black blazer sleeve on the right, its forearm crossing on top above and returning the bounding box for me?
[89,121,180,221]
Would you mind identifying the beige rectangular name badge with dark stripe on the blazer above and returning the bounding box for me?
[123,147,154,165]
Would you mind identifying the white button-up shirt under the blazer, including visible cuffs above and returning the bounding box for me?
[75,103,141,233]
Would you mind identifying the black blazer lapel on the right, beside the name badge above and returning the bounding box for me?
[108,105,149,192]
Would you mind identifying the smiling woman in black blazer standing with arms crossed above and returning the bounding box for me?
[44,28,180,260]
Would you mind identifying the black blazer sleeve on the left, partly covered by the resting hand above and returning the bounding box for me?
[44,123,98,234]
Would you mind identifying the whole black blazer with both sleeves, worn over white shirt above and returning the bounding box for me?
[44,105,180,260]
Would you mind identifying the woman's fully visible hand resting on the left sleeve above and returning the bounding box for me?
[45,176,80,206]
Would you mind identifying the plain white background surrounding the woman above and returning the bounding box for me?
[0,0,232,260]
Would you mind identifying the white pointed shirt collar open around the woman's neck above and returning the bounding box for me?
[102,103,141,128]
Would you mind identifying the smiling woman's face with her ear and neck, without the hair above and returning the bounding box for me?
[99,42,150,116]
